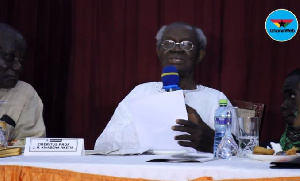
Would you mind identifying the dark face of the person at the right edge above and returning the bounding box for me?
[281,75,300,124]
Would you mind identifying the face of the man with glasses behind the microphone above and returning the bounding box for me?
[157,24,198,73]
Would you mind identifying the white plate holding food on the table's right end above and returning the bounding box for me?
[247,153,300,162]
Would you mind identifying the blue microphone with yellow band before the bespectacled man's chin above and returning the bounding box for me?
[161,65,181,92]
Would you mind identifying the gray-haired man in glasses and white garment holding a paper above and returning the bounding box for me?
[95,22,234,152]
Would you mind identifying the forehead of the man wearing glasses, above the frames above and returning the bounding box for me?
[163,24,196,39]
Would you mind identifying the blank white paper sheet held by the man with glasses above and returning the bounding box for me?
[129,90,189,152]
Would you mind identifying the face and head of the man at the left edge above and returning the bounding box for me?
[0,33,26,89]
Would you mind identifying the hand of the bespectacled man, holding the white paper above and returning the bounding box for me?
[172,105,214,152]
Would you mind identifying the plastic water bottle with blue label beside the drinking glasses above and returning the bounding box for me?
[214,99,231,157]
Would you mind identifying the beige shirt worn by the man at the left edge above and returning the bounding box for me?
[0,81,46,140]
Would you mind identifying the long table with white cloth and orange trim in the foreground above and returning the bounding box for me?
[0,155,300,181]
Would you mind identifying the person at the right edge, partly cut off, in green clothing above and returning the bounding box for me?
[280,69,300,151]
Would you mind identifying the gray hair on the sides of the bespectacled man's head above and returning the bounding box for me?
[155,23,207,50]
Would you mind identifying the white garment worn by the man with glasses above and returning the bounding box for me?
[95,82,236,152]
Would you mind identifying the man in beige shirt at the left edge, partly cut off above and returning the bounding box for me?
[0,23,46,144]
